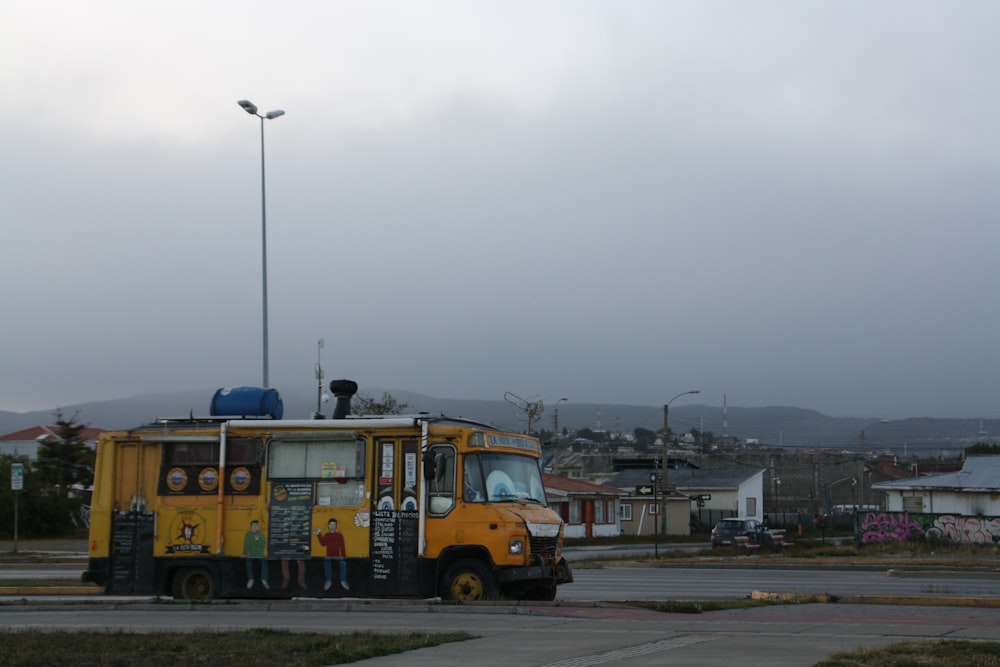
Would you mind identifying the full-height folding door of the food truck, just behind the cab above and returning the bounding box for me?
[370,438,421,597]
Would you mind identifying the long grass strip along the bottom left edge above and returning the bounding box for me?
[0,628,473,667]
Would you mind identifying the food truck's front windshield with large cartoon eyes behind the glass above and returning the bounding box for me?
[464,453,545,505]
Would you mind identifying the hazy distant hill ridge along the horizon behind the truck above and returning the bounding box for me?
[0,387,1000,453]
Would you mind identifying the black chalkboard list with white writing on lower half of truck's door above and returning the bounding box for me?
[371,509,419,595]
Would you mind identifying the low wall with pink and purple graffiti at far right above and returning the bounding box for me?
[857,512,1000,544]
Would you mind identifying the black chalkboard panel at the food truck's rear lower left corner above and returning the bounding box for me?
[108,512,154,593]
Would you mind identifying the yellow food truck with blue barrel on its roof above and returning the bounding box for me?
[83,380,573,600]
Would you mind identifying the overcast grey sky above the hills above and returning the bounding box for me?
[0,0,1000,418]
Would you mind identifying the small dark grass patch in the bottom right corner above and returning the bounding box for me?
[814,639,1000,667]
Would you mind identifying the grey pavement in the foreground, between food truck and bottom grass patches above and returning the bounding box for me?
[0,601,1000,667]
